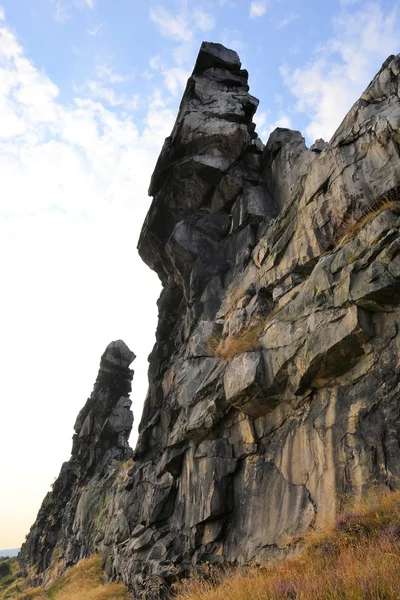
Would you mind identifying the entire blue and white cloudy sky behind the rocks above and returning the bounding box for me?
[0,0,400,548]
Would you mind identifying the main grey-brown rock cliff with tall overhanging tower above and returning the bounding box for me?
[23,43,400,598]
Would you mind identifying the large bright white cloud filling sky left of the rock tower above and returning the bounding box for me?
[0,15,175,547]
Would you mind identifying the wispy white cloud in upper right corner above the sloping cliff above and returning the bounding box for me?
[281,2,400,141]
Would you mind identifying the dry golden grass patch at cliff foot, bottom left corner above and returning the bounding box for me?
[0,556,128,600]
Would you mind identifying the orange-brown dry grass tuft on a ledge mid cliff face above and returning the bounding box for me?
[208,320,265,360]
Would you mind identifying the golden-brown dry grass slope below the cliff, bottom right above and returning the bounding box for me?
[174,492,400,600]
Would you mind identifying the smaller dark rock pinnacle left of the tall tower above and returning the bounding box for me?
[20,340,136,580]
